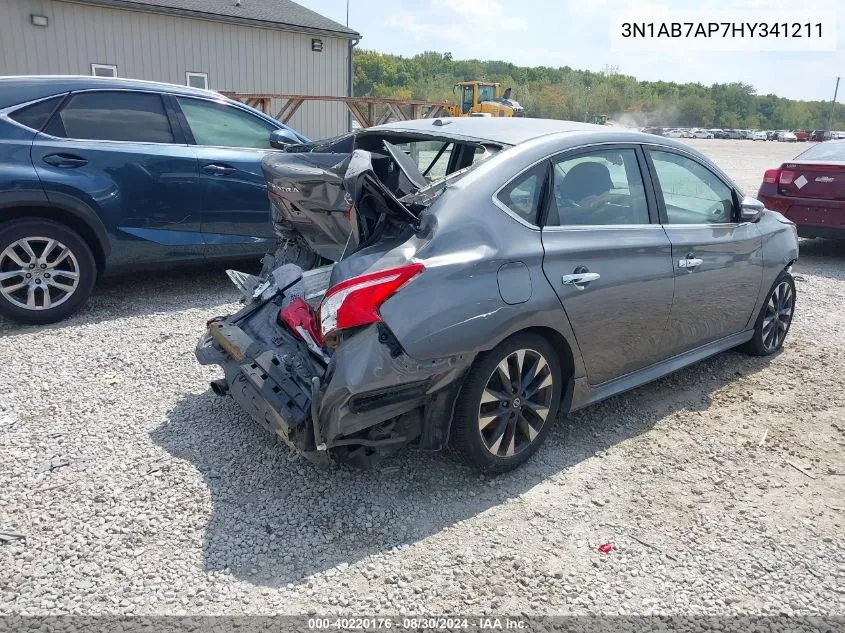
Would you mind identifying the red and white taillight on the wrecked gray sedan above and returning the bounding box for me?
[320,262,425,336]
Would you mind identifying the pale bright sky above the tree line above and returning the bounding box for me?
[296,0,845,103]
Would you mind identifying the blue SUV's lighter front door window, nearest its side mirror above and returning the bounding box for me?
[177,97,276,149]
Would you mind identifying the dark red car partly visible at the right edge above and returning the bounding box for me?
[757,141,845,239]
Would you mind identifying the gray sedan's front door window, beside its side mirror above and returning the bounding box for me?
[649,150,734,224]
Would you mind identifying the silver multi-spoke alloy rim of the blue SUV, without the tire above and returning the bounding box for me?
[0,237,79,310]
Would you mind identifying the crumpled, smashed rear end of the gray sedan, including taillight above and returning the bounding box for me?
[196,148,466,466]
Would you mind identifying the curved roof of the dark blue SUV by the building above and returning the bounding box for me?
[0,75,237,108]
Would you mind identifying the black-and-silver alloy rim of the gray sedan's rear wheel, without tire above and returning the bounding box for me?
[478,349,553,457]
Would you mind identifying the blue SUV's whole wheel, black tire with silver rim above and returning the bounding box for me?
[0,218,97,325]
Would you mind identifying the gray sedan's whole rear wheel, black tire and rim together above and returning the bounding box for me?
[449,334,563,473]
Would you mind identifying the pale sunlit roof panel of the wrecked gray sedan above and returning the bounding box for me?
[366,117,613,145]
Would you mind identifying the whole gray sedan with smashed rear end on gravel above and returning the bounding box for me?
[197,118,798,472]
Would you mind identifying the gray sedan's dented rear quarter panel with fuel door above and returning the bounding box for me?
[380,143,583,376]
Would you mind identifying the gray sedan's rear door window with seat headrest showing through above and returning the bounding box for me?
[546,149,649,226]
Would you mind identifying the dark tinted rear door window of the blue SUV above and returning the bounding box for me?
[44,92,173,143]
